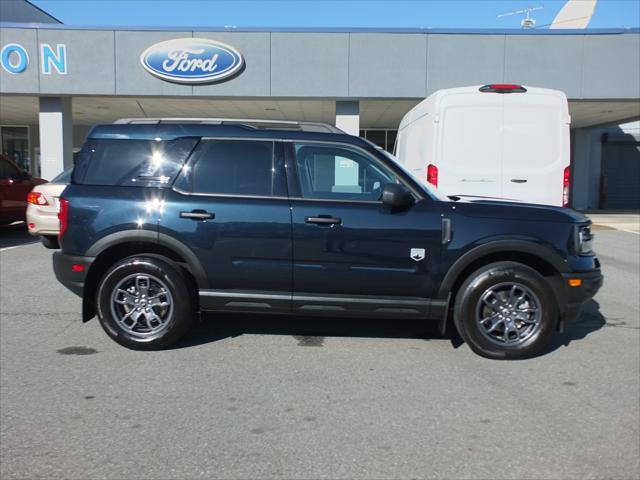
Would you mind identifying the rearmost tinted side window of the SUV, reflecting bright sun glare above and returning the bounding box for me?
[72,138,198,186]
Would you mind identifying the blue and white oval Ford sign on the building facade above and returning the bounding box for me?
[140,38,244,83]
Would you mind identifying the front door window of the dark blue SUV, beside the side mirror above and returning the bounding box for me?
[294,143,397,202]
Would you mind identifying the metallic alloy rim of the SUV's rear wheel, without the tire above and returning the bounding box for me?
[111,273,173,338]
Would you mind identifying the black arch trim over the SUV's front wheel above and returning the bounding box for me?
[437,240,570,299]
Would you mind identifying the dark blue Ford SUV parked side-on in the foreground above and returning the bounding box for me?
[53,120,602,358]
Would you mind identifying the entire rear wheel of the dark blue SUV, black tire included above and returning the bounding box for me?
[96,255,194,350]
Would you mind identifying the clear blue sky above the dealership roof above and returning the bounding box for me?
[27,0,640,29]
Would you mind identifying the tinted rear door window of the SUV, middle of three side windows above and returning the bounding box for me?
[175,140,287,196]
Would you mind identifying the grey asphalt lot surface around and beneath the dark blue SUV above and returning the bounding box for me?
[0,226,640,480]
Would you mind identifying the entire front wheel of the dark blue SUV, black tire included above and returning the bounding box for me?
[453,262,558,359]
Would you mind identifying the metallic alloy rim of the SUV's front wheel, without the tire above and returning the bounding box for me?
[476,282,542,346]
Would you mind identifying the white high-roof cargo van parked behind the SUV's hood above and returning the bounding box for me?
[395,84,571,206]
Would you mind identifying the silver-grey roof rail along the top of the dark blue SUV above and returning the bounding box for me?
[113,117,345,133]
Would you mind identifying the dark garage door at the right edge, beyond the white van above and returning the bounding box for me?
[600,135,640,210]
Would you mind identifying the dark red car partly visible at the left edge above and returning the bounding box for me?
[0,155,47,225]
